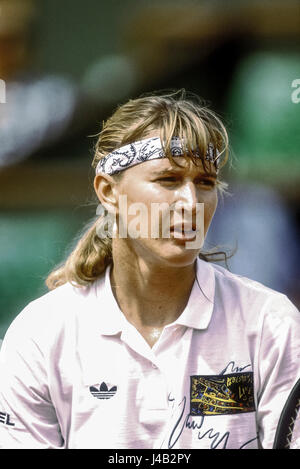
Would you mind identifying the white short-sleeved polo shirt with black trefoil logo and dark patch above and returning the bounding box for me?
[0,260,300,449]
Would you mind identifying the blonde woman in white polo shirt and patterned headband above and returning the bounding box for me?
[0,92,300,449]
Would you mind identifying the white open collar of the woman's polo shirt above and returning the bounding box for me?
[95,259,215,335]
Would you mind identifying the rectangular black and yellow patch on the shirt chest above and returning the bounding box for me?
[190,372,255,415]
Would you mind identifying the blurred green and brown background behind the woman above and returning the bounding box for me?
[0,0,300,337]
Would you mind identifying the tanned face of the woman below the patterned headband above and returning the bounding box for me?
[113,157,218,266]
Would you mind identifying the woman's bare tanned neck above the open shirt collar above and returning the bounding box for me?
[111,239,195,332]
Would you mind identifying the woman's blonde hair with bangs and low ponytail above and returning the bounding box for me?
[46,90,228,290]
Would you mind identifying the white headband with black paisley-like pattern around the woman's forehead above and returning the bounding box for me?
[96,137,220,175]
